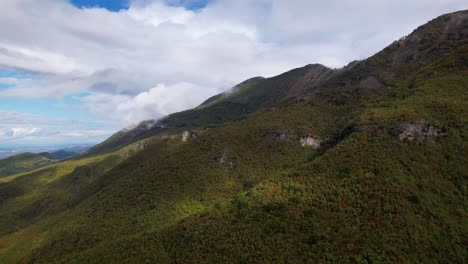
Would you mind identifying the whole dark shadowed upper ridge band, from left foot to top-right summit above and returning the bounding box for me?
[86,11,468,157]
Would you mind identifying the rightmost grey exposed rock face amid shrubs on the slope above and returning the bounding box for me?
[398,118,442,142]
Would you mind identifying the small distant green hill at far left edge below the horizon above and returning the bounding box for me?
[0,153,56,178]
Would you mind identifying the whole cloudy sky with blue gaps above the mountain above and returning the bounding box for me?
[0,0,468,147]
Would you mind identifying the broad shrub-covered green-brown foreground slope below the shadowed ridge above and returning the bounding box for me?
[0,10,468,263]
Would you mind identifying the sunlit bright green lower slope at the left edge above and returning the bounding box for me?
[0,136,159,239]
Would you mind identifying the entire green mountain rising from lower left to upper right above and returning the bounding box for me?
[0,11,468,263]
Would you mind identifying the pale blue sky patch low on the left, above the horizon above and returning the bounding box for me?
[0,69,119,148]
